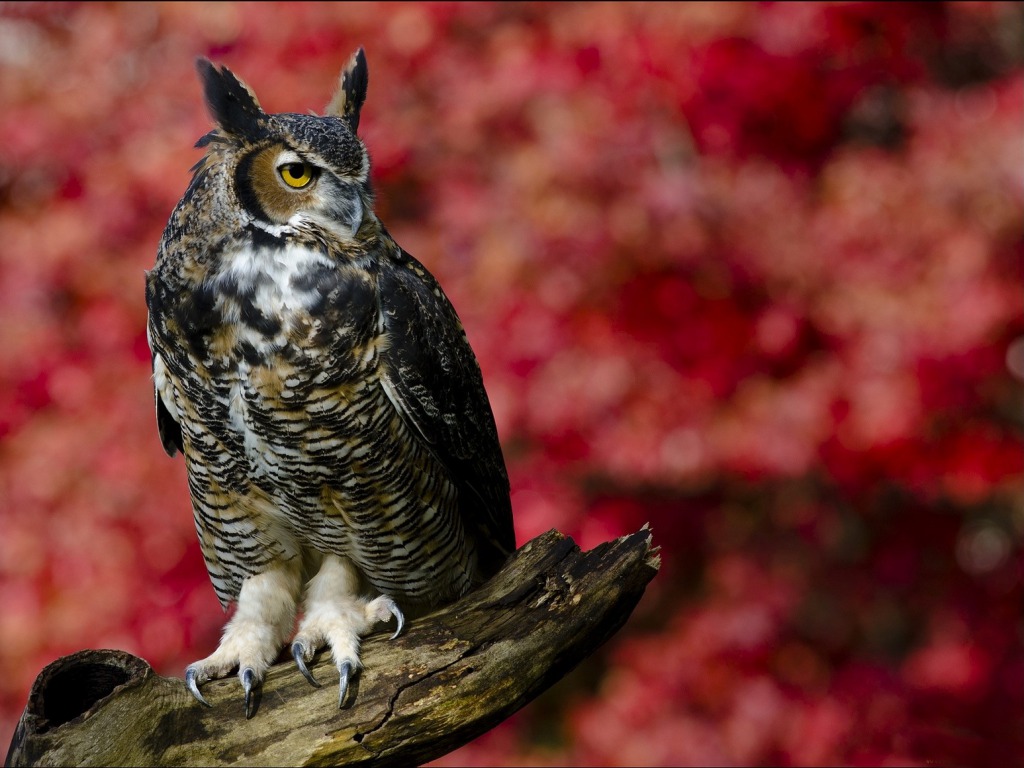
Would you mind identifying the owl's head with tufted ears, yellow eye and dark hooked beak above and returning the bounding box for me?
[196,48,371,239]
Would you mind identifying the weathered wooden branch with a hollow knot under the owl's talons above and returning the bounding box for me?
[6,526,660,767]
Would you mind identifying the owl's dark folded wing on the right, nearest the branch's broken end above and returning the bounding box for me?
[379,251,515,575]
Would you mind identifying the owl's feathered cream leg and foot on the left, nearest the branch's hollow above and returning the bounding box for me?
[185,568,299,719]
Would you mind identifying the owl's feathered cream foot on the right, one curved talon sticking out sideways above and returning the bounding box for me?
[292,555,406,708]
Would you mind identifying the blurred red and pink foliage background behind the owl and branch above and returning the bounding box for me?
[0,3,1024,766]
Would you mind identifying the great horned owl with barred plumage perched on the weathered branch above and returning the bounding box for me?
[145,48,515,717]
